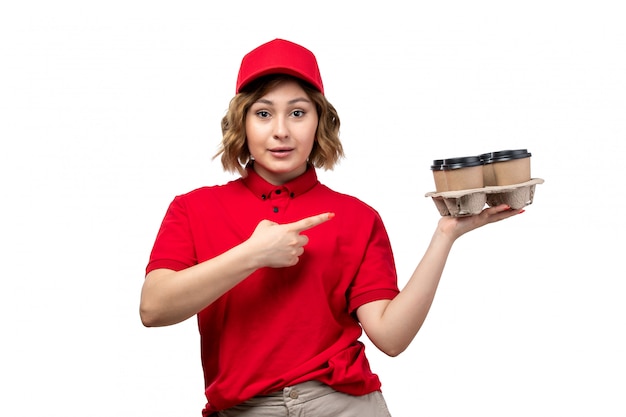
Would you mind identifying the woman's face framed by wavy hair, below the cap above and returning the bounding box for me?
[246,80,318,185]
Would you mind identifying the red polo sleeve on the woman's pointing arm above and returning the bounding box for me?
[146,196,197,274]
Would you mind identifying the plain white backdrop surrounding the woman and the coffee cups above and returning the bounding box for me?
[0,0,626,417]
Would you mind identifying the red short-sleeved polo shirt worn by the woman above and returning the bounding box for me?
[146,167,399,416]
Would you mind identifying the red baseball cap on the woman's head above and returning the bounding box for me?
[236,39,324,94]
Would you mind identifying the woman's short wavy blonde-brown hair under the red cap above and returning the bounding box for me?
[213,74,344,176]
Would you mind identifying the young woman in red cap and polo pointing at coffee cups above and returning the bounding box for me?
[140,39,520,417]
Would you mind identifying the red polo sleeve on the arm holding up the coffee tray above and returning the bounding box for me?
[348,213,400,313]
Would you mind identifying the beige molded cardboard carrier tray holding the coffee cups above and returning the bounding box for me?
[426,178,543,217]
